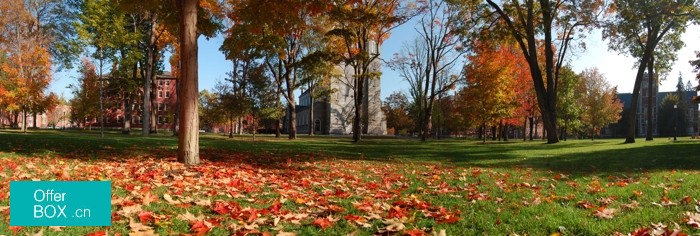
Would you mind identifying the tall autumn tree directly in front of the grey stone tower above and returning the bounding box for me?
[328,0,413,142]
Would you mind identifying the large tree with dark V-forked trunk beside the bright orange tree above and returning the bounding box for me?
[452,0,604,143]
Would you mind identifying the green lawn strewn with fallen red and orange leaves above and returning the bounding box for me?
[0,130,700,235]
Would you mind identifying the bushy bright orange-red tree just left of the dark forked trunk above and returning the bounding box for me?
[457,42,535,141]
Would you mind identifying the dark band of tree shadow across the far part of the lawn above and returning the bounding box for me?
[0,130,700,175]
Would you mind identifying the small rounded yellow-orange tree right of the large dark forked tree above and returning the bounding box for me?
[580,68,622,140]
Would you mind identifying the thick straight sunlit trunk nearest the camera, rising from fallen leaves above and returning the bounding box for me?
[177,0,200,165]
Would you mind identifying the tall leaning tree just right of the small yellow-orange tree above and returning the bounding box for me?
[603,0,699,143]
